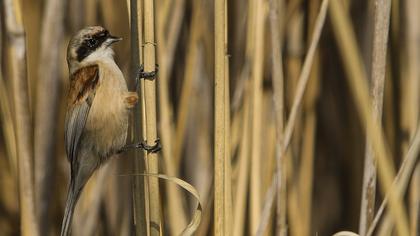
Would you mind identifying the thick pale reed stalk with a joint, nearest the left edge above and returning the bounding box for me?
[3,0,39,236]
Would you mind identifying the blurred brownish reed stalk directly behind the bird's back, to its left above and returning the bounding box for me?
[34,0,66,235]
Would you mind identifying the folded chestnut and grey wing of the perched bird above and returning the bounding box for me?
[64,65,99,164]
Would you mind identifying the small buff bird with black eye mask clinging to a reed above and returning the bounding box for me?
[61,26,138,236]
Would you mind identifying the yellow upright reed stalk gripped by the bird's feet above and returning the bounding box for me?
[144,0,161,236]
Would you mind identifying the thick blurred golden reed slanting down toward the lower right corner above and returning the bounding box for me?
[330,1,408,235]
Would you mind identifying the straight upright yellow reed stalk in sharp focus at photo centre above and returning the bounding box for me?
[214,0,232,236]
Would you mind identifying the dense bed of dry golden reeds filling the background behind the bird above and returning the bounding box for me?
[0,0,420,236]
